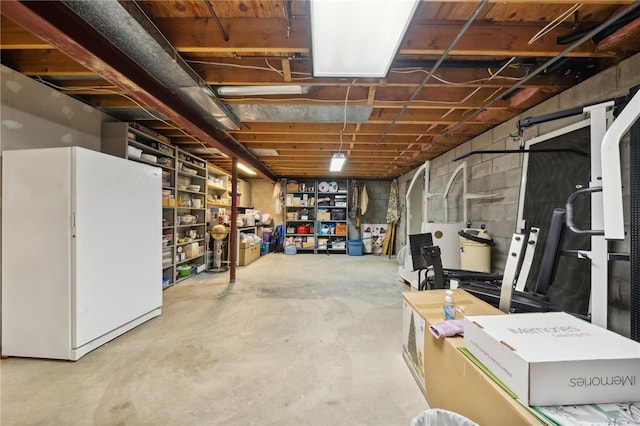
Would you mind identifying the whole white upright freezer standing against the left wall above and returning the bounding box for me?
[2,147,162,360]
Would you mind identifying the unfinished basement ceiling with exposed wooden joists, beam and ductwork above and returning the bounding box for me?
[0,0,640,180]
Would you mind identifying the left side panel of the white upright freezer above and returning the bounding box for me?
[2,148,71,359]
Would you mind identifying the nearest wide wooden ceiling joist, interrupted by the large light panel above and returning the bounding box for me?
[155,18,609,58]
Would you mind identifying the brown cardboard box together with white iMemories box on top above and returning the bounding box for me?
[402,290,640,425]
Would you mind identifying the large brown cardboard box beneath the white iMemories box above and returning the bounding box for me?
[402,290,541,426]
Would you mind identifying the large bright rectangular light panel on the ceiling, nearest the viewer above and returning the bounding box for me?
[311,0,419,78]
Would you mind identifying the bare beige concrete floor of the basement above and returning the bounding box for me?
[0,253,428,426]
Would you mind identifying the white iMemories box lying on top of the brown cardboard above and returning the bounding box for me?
[464,312,640,406]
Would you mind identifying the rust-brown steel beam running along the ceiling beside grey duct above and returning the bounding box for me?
[2,0,276,182]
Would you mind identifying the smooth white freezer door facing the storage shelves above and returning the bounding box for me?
[72,147,162,349]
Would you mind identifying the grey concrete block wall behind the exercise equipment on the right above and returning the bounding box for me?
[403,54,640,336]
